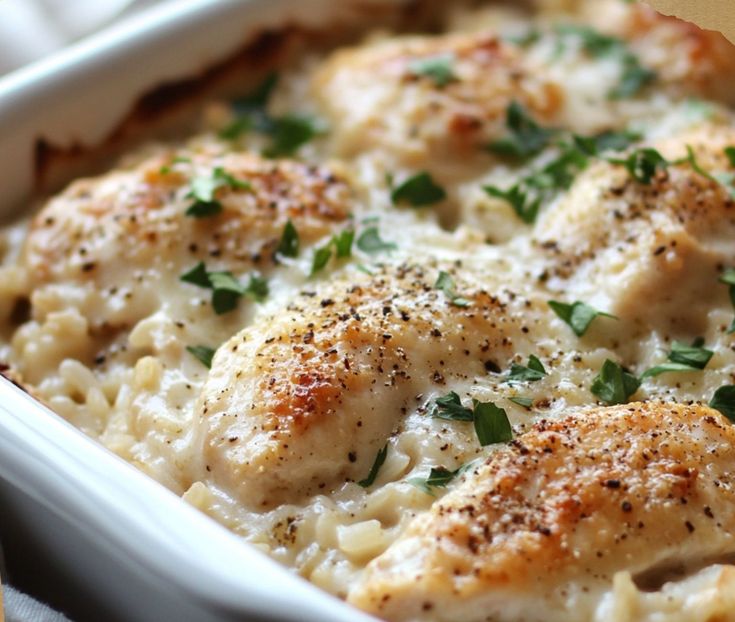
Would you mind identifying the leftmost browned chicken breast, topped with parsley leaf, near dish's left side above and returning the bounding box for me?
[22,146,352,329]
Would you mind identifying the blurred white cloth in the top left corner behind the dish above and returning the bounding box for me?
[0,0,156,75]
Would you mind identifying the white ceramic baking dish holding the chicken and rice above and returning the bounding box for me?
[0,0,408,622]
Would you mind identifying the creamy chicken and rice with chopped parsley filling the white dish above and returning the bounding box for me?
[7,0,735,622]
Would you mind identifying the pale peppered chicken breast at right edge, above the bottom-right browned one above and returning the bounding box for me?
[536,125,735,332]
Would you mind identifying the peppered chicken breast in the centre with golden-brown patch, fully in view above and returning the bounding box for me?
[197,265,548,508]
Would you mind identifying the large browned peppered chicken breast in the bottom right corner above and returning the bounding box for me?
[348,402,735,622]
